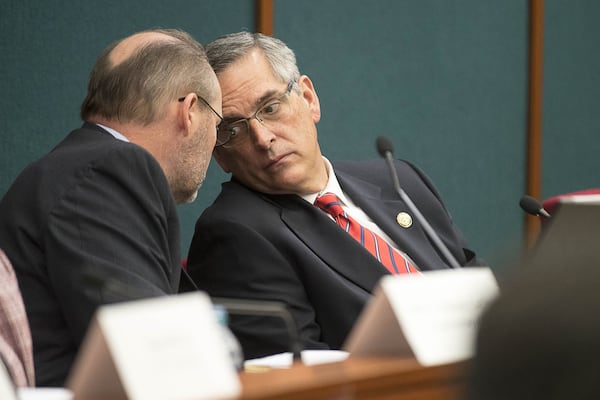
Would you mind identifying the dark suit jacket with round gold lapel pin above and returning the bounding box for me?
[182,160,476,358]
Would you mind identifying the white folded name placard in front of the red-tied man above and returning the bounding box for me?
[344,267,498,366]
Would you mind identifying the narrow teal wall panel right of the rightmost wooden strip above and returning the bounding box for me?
[542,0,600,197]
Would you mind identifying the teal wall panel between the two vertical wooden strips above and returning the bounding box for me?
[274,0,528,265]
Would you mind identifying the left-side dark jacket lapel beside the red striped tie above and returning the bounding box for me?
[269,195,387,292]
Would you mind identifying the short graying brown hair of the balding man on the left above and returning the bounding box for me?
[81,29,218,125]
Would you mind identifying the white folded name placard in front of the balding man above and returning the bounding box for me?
[67,292,241,400]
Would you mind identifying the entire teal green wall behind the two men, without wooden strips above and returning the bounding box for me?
[0,0,600,268]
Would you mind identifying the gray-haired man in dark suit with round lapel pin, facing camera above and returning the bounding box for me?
[182,32,477,358]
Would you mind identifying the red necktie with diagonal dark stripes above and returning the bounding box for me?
[315,193,419,274]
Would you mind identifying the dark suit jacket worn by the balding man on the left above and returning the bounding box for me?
[0,123,181,386]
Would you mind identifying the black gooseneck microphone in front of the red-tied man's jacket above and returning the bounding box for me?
[377,136,461,268]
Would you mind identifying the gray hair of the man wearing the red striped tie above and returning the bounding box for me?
[206,32,300,83]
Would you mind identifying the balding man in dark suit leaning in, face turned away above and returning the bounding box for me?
[0,30,221,386]
